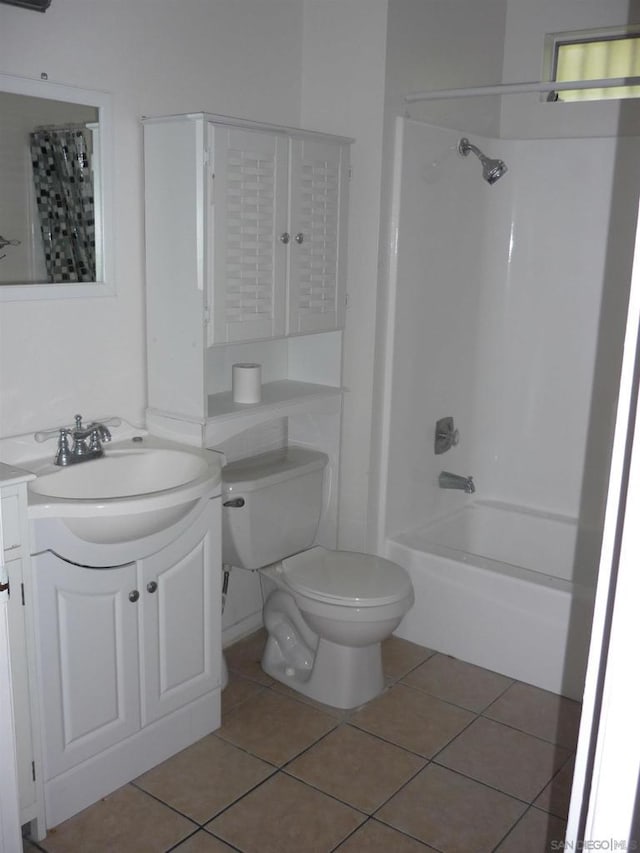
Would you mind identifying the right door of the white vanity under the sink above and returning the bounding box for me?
[138,498,221,725]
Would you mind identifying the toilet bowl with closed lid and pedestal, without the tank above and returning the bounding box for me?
[262,548,414,709]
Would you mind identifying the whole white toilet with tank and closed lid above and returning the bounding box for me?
[222,446,414,709]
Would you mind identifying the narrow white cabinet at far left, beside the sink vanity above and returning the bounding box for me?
[0,472,45,839]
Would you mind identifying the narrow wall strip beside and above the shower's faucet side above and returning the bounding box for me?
[367,0,506,550]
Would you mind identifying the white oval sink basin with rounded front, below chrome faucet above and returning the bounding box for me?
[22,436,220,545]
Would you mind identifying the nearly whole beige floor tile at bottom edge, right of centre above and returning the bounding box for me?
[376,764,526,853]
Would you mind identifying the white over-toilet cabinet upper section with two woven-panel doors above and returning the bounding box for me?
[144,114,352,430]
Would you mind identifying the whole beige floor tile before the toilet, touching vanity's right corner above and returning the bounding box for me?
[216,690,337,765]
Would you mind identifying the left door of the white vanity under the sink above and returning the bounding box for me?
[33,552,140,779]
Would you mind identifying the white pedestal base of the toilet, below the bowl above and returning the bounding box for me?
[262,635,384,710]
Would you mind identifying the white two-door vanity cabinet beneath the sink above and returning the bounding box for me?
[33,498,221,826]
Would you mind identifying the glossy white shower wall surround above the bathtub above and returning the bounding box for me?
[387,121,634,534]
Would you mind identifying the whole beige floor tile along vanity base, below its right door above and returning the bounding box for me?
[135,735,274,824]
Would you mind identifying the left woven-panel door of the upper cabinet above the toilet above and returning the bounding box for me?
[209,125,288,343]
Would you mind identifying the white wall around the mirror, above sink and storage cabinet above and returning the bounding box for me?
[0,0,303,437]
